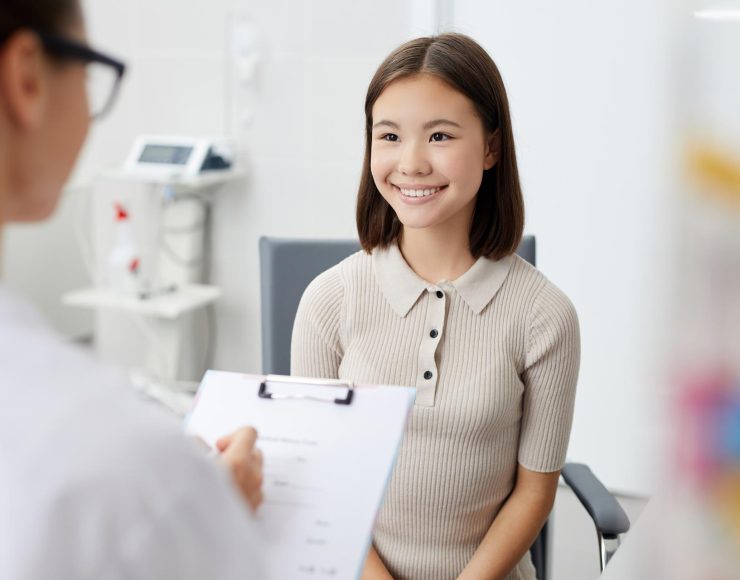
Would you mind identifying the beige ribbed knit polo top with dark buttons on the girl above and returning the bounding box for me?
[291,245,580,580]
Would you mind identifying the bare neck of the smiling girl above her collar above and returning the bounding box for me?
[398,222,475,284]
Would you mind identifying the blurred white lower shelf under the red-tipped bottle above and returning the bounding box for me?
[62,284,221,320]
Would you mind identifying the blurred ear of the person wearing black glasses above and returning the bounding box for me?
[0,32,47,129]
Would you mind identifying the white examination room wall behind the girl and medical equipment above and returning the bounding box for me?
[2,0,684,495]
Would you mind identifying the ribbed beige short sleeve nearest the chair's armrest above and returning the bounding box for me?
[519,281,581,473]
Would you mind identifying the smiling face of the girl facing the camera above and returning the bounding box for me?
[370,74,498,236]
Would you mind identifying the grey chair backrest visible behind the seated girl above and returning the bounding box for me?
[259,236,548,580]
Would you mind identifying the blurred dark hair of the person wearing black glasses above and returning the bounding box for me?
[0,0,82,43]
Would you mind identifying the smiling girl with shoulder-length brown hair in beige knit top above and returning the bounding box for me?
[291,34,580,580]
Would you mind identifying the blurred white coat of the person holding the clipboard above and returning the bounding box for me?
[0,285,262,580]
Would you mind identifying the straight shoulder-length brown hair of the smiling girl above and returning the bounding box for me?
[356,33,524,260]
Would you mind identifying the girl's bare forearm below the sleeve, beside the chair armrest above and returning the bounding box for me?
[456,465,560,580]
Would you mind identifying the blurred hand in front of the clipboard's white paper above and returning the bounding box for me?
[216,427,263,511]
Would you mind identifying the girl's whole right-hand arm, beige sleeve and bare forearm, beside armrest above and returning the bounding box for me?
[460,284,580,580]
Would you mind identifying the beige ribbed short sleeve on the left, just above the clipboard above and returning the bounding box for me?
[290,266,344,379]
